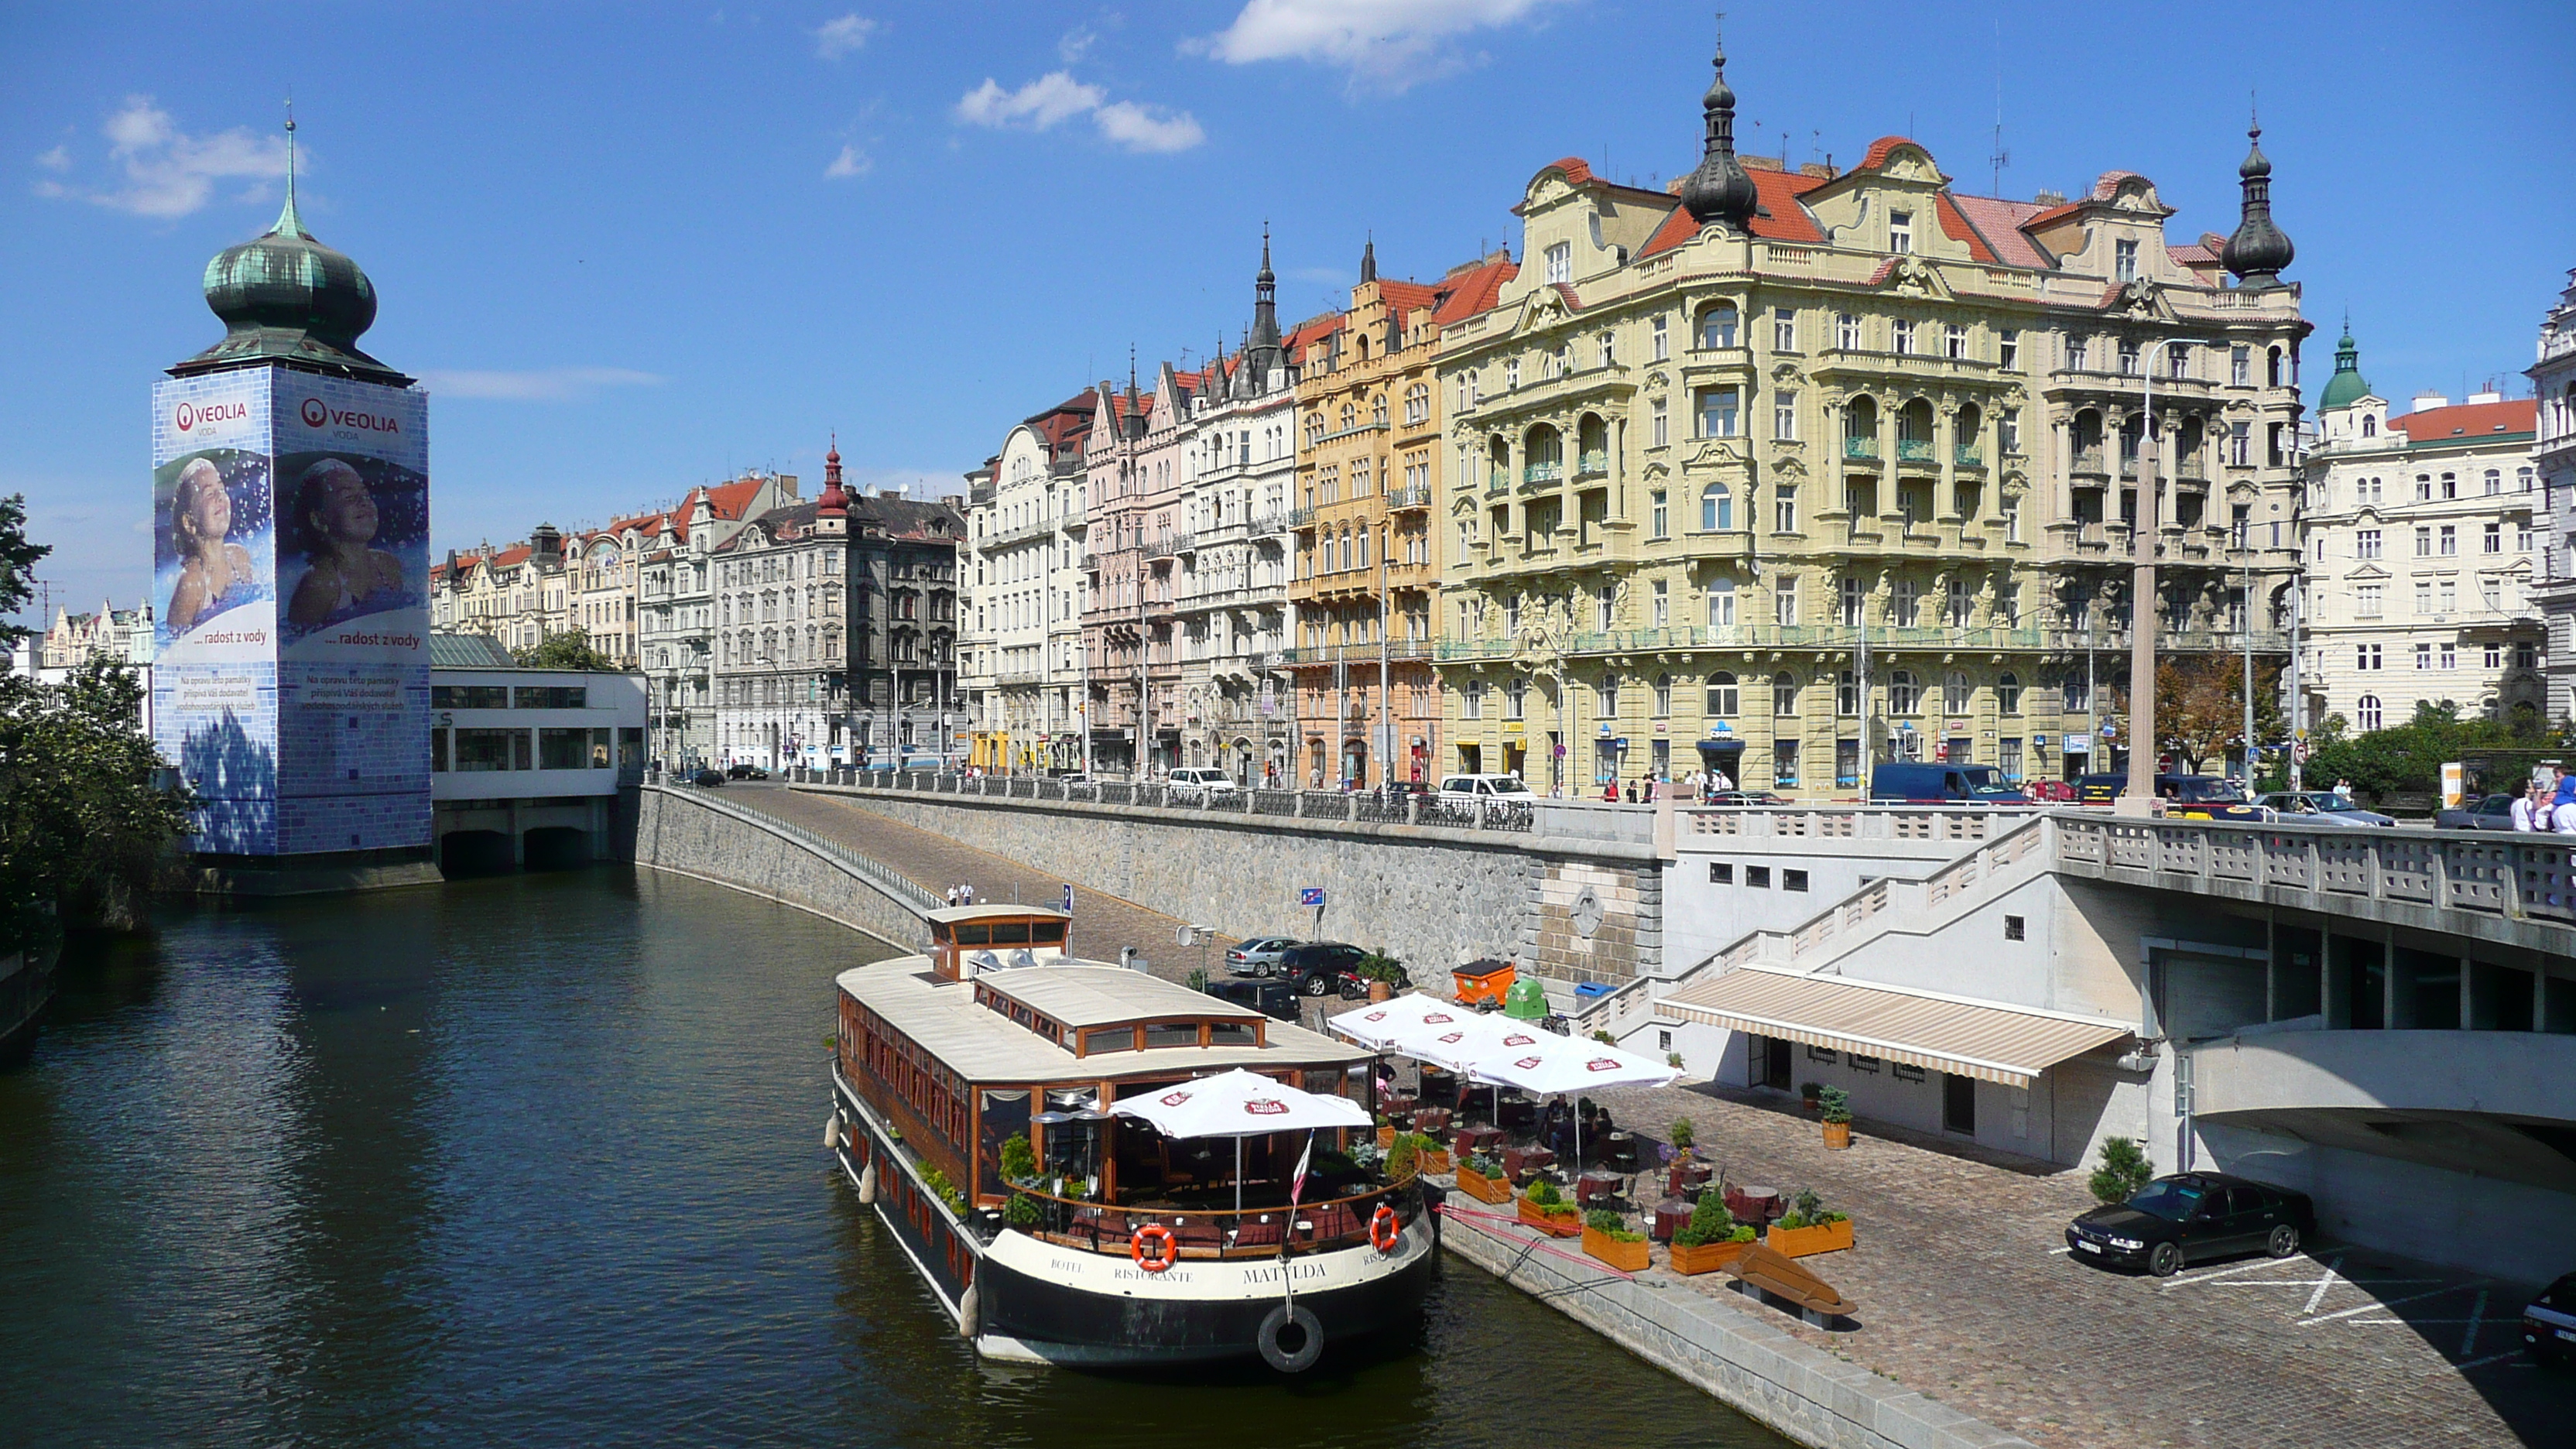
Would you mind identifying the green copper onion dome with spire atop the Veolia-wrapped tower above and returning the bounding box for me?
[170,122,412,387]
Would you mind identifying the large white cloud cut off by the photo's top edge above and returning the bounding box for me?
[1187,0,1556,91]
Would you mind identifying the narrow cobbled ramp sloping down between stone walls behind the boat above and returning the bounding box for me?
[724,784,1234,982]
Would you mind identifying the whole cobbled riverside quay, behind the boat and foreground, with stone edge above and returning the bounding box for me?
[664,786,2576,1449]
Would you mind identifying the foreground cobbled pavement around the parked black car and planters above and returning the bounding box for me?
[1595,1085,2576,1449]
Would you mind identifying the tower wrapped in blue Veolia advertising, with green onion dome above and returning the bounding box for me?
[152,122,430,876]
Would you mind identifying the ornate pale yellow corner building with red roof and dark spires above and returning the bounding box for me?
[1442,36,2308,796]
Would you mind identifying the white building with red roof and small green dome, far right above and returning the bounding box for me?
[2300,333,2547,730]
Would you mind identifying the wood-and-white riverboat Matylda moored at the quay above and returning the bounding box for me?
[830,905,1437,1372]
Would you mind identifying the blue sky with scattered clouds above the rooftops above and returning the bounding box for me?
[0,0,2576,621]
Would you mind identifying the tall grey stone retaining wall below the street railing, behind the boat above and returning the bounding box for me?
[796,784,1664,985]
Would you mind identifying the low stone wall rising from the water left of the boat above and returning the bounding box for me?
[634,789,927,951]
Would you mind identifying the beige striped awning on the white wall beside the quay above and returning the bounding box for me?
[1654,967,2136,1088]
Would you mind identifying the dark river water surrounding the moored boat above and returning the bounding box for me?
[0,869,1785,1449]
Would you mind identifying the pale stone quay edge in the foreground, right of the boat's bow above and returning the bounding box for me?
[1440,1199,2033,1449]
